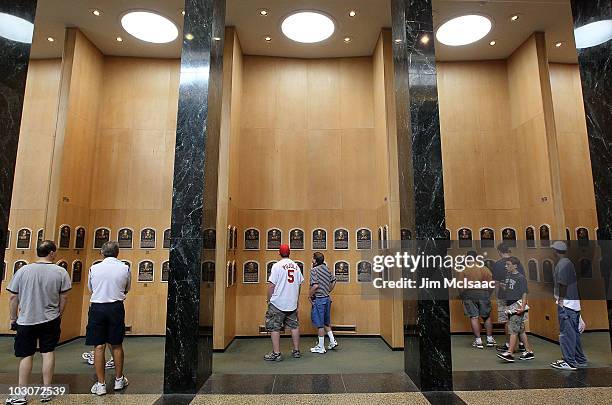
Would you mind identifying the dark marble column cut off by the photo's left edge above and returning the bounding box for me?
[0,0,36,263]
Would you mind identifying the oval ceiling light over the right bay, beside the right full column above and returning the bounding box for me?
[436,15,493,46]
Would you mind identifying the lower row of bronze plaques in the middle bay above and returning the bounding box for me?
[226,260,372,287]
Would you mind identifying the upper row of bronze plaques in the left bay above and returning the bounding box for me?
[6,225,170,250]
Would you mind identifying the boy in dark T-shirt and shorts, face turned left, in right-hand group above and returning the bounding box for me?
[497,257,535,363]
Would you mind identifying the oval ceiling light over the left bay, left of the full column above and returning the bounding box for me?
[121,11,178,44]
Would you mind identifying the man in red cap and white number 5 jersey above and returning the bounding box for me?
[264,244,304,361]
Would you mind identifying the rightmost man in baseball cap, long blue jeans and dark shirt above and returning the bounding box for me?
[550,241,587,371]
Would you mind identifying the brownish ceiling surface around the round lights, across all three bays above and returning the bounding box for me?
[32,0,576,63]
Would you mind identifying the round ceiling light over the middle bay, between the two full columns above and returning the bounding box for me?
[281,11,336,44]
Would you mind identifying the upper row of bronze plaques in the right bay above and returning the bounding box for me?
[454,225,590,247]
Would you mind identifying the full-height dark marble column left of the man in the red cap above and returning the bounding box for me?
[164,0,225,394]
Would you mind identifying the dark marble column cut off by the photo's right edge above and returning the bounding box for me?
[572,0,612,346]
